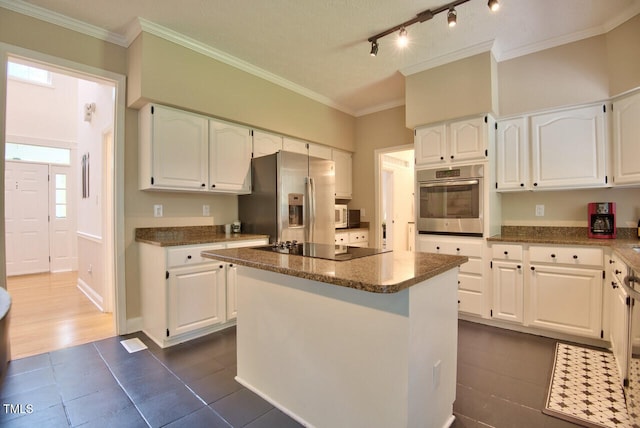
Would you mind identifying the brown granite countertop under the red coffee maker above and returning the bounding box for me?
[487,226,640,272]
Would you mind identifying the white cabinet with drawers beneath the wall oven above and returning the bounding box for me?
[417,235,487,316]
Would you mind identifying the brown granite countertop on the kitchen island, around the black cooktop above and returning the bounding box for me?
[202,248,468,293]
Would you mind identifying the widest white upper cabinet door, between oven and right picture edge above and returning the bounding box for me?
[531,105,606,188]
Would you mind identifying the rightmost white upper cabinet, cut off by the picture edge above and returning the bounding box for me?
[613,93,640,185]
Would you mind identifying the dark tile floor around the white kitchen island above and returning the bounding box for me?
[0,321,588,428]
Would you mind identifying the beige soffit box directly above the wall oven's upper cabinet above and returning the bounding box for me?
[405,52,496,129]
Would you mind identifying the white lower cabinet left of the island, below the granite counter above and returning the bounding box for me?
[138,239,268,348]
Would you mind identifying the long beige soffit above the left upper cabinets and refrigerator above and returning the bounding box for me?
[128,33,355,151]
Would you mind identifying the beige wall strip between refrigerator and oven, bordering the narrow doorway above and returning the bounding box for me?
[349,106,413,243]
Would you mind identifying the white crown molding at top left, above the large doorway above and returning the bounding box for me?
[0,0,129,48]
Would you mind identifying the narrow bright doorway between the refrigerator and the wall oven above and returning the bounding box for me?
[376,145,415,251]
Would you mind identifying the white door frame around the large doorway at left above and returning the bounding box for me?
[0,43,128,335]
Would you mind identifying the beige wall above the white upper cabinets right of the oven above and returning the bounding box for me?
[498,36,609,117]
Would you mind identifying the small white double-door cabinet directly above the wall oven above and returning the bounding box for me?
[414,116,488,165]
